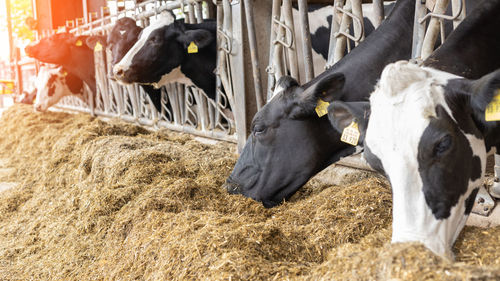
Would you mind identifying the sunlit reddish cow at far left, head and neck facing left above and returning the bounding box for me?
[26,32,96,93]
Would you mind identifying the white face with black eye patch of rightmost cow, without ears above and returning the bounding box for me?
[365,62,486,258]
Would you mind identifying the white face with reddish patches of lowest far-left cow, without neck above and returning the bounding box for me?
[33,66,73,112]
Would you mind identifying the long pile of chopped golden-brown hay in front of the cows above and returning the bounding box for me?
[0,106,500,280]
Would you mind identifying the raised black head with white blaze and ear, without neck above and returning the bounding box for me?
[113,13,215,86]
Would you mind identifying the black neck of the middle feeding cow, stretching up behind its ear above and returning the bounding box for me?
[313,0,415,101]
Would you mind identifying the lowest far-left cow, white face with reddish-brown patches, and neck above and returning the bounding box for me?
[33,66,84,112]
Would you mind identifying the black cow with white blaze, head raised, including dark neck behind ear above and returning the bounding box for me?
[113,18,217,99]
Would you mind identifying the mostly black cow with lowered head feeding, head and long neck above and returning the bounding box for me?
[225,0,415,207]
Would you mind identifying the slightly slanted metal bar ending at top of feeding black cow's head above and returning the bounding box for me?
[298,0,314,82]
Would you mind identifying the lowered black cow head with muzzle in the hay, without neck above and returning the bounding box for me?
[225,73,355,207]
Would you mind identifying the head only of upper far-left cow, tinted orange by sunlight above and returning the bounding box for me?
[25,32,87,65]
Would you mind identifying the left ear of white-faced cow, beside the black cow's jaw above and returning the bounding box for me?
[328,101,370,143]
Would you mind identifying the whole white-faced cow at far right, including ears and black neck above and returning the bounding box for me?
[330,0,500,258]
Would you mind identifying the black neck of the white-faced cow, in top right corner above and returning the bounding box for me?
[424,0,500,79]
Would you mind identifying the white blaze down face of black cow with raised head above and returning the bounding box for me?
[113,13,175,75]
